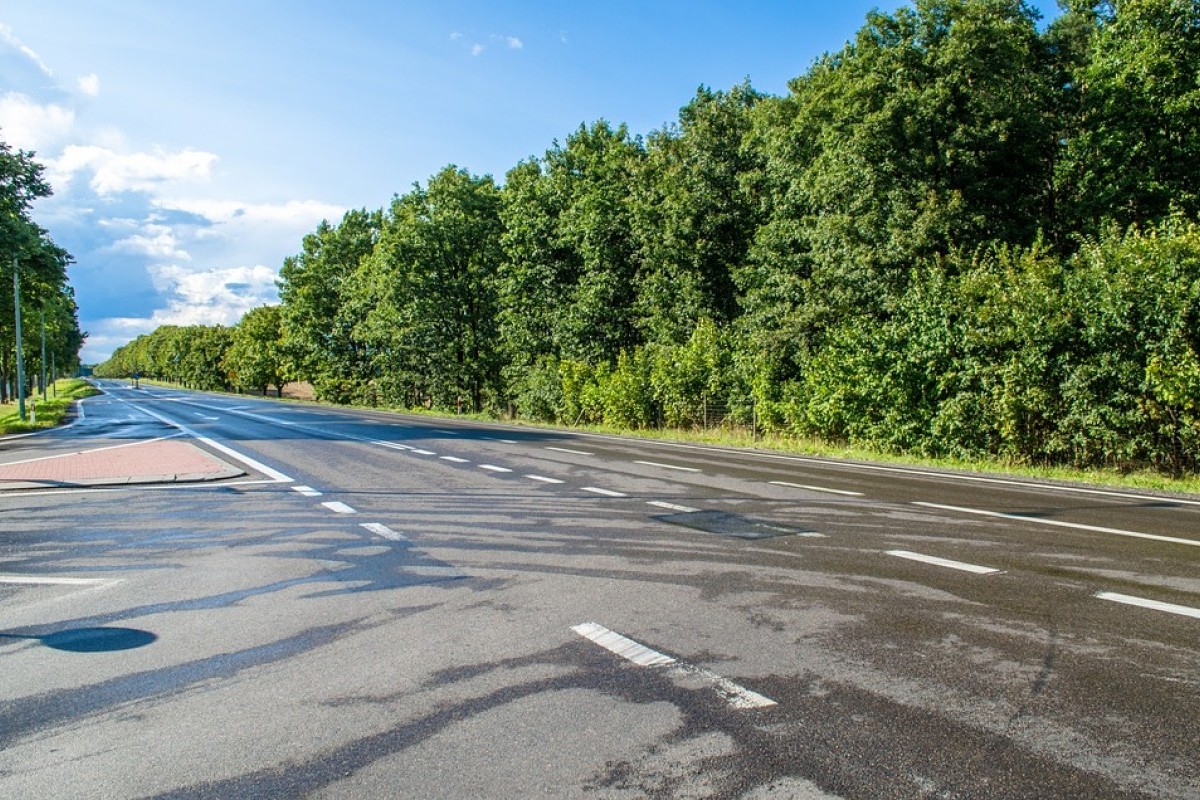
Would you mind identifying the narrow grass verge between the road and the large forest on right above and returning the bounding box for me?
[124,380,1200,495]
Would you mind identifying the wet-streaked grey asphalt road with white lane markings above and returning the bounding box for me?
[0,384,1200,799]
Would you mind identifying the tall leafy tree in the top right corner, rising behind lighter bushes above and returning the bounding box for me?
[1057,0,1200,234]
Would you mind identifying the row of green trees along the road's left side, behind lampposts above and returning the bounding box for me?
[0,136,86,403]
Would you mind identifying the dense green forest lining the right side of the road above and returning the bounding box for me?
[103,0,1200,474]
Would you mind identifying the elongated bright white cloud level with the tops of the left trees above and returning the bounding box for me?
[47,145,217,194]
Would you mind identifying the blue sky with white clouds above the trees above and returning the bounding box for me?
[0,0,1049,361]
